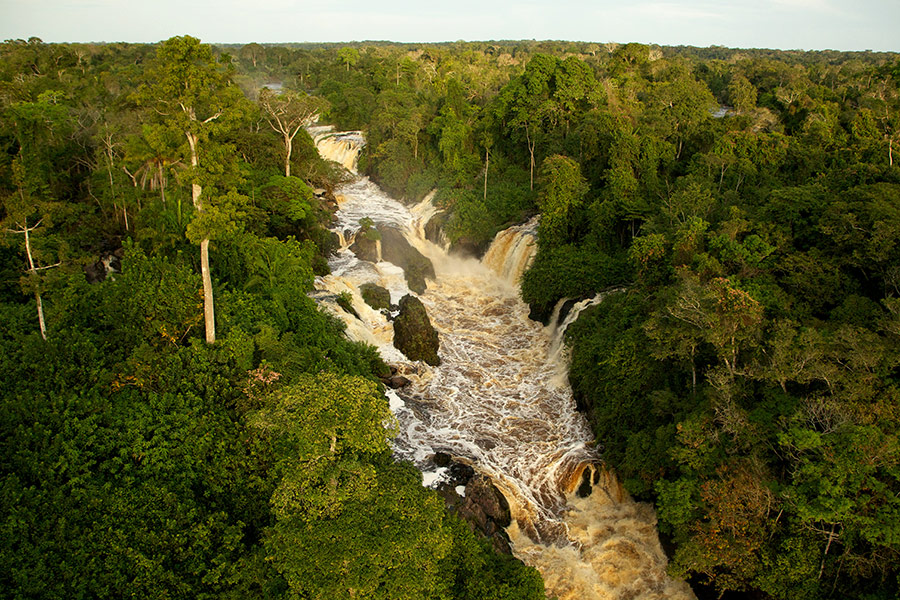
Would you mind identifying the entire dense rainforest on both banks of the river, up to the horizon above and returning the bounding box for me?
[0,37,900,600]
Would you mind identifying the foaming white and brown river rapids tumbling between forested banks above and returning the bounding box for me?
[317,131,693,600]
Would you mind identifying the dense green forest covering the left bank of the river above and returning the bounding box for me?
[0,37,544,600]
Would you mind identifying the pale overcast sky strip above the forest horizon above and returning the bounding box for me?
[0,0,900,51]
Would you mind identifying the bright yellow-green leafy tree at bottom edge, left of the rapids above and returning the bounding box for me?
[252,373,450,599]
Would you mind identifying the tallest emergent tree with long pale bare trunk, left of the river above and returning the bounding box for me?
[138,36,243,344]
